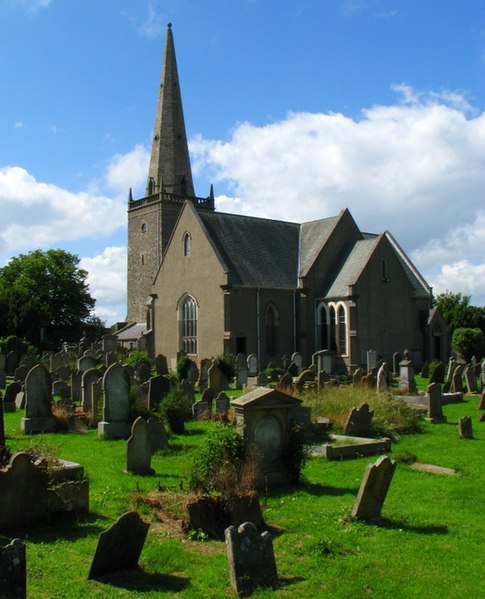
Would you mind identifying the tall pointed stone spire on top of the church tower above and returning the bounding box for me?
[146,23,195,197]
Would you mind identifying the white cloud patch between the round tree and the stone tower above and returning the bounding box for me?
[80,247,126,324]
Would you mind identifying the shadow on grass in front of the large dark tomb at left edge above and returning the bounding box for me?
[9,513,108,543]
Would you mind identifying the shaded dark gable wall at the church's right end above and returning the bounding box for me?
[352,238,429,366]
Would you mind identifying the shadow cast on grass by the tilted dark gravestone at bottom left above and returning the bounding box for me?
[94,567,190,593]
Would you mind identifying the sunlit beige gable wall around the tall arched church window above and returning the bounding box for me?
[154,204,227,368]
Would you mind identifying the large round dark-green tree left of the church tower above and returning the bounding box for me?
[0,250,95,348]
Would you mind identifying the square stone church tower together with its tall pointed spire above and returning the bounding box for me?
[126,24,214,322]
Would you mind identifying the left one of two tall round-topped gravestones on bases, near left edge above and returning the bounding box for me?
[20,364,56,434]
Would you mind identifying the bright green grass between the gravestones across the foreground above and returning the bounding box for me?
[0,396,485,599]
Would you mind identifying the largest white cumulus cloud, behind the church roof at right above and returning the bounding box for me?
[191,84,485,303]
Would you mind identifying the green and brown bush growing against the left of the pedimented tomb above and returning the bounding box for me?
[190,424,257,498]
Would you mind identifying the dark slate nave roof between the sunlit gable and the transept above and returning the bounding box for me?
[197,210,300,289]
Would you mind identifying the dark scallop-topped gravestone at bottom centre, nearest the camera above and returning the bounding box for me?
[224,522,278,595]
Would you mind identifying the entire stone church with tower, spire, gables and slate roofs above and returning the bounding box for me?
[127,25,449,373]
